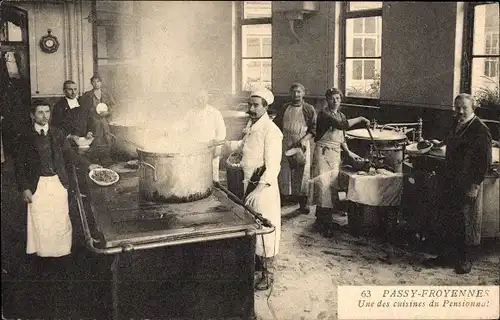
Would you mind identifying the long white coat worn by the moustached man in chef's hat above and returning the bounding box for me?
[230,113,283,257]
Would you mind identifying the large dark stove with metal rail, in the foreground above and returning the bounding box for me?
[74,165,273,319]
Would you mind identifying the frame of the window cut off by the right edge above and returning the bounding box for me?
[460,1,500,94]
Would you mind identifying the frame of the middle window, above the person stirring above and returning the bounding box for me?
[338,1,383,105]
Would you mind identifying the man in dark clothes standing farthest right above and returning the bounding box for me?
[426,93,492,274]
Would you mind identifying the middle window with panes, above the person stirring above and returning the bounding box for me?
[339,1,382,99]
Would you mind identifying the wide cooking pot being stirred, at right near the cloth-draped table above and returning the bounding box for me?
[346,129,408,172]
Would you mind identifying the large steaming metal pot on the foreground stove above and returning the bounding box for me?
[137,141,224,203]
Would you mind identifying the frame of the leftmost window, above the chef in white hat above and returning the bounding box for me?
[235,1,273,96]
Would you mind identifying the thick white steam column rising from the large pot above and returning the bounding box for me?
[114,1,227,153]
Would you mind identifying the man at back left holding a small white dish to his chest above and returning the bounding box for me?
[80,74,115,165]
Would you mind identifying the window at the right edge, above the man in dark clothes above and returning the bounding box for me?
[462,2,500,95]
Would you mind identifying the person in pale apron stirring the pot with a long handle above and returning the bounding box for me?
[309,88,370,236]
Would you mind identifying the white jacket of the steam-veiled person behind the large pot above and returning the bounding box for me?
[189,105,226,181]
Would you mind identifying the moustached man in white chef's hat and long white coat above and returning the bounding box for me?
[229,88,283,290]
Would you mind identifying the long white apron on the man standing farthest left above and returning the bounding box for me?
[26,175,73,257]
